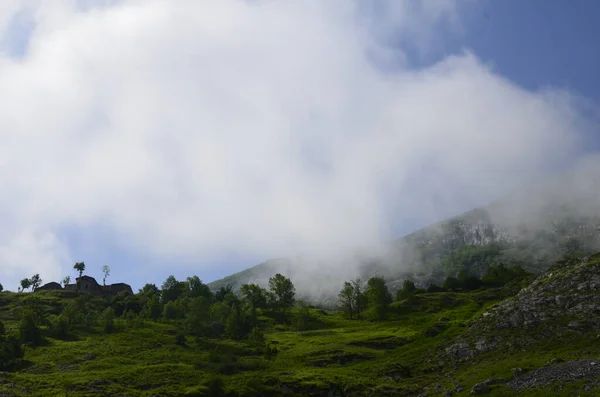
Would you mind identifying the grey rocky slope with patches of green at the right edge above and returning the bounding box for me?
[446,254,600,361]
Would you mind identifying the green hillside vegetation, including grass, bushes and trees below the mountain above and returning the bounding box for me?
[0,252,600,396]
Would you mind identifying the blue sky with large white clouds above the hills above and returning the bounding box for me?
[0,0,600,290]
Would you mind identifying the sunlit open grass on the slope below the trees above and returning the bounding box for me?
[0,290,599,396]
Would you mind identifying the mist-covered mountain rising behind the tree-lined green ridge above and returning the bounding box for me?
[209,161,600,302]
